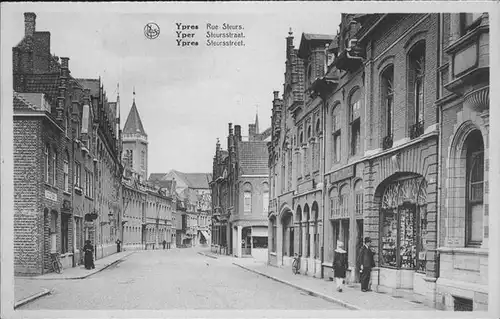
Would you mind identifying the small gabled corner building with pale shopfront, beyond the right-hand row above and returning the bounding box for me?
[210,121,270,260]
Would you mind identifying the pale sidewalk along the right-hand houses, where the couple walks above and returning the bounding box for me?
[198,251,437,311]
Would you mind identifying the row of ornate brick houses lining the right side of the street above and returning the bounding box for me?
[268,13,489,310]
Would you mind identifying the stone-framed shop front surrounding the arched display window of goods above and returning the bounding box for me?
[363,138,438,304]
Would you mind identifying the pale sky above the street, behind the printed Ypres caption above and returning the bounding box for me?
[2,2,340,174]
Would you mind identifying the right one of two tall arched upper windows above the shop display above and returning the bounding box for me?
[408,41,425,138]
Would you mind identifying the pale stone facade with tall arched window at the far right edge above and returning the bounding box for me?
[435,13,493,310]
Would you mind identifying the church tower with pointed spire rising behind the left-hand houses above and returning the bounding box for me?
[122,89,148,181]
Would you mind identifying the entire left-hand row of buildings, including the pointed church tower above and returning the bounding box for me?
[12,12,211,275]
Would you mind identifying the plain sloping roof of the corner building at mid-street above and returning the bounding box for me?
[238,141,269,175]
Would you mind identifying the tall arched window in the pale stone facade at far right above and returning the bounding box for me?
[466,131,484,247]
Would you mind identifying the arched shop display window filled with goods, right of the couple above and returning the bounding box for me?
[379,175,427,271]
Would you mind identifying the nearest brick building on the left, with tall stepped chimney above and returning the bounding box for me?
[12,12,92,275]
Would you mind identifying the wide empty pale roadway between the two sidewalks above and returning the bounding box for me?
[16,248,346,310]
